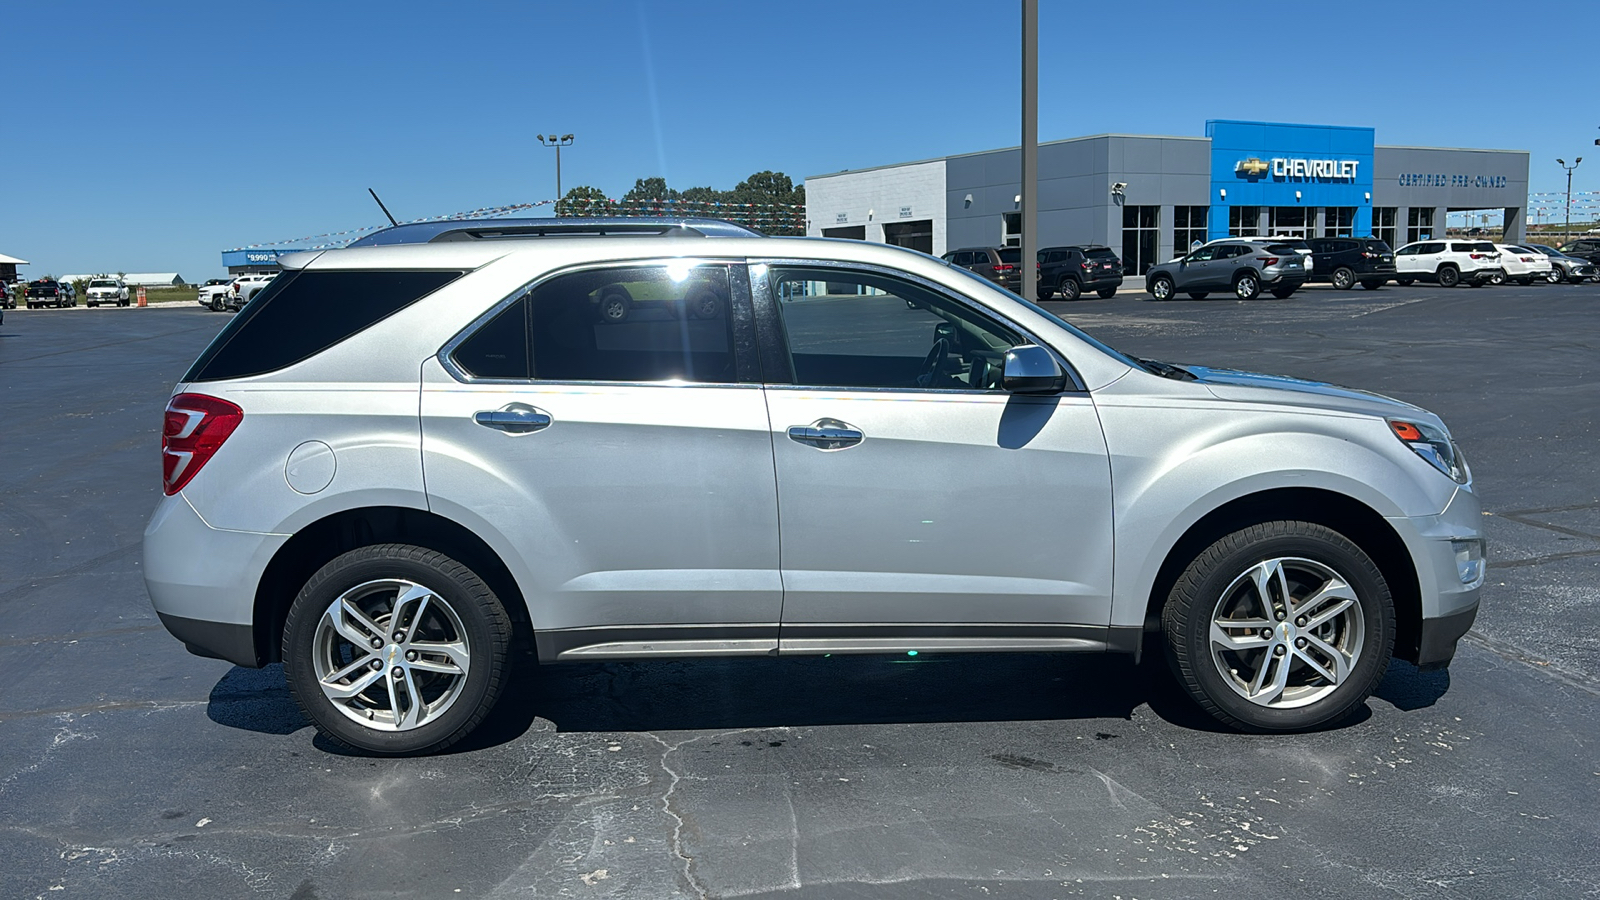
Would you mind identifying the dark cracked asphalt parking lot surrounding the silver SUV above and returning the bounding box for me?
[0,285,1600,900]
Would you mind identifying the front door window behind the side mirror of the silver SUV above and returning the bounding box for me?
[771,267,1021,391]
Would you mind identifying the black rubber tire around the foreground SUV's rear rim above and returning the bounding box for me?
[283,544,512,756]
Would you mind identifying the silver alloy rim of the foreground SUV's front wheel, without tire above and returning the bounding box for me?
[1210,557,1366,709]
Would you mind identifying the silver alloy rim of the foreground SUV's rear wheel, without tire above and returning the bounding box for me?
[312,578,472,732]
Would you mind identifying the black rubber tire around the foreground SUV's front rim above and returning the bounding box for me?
[1162,520,1395,732]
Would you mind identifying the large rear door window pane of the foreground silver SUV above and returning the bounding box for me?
[528,264,738,384]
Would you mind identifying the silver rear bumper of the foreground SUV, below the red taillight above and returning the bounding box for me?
[144,493,290,668]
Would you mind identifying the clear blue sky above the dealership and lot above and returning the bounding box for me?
[0,0,1600,279]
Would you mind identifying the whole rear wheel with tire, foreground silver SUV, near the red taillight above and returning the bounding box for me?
[283,544,512,754]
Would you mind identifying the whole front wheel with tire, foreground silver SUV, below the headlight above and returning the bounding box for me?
[1162,520,1395,732]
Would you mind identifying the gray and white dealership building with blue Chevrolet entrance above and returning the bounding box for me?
[805,120,1528,274]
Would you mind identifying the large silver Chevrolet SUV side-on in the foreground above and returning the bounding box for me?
[144,226,1485,753]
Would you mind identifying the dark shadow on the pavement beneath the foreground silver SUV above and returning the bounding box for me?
[206,652,1450,754]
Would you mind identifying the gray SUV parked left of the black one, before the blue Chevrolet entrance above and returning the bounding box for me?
[1144,240,1306,299]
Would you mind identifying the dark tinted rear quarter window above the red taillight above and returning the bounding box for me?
[184,271,461,381]
